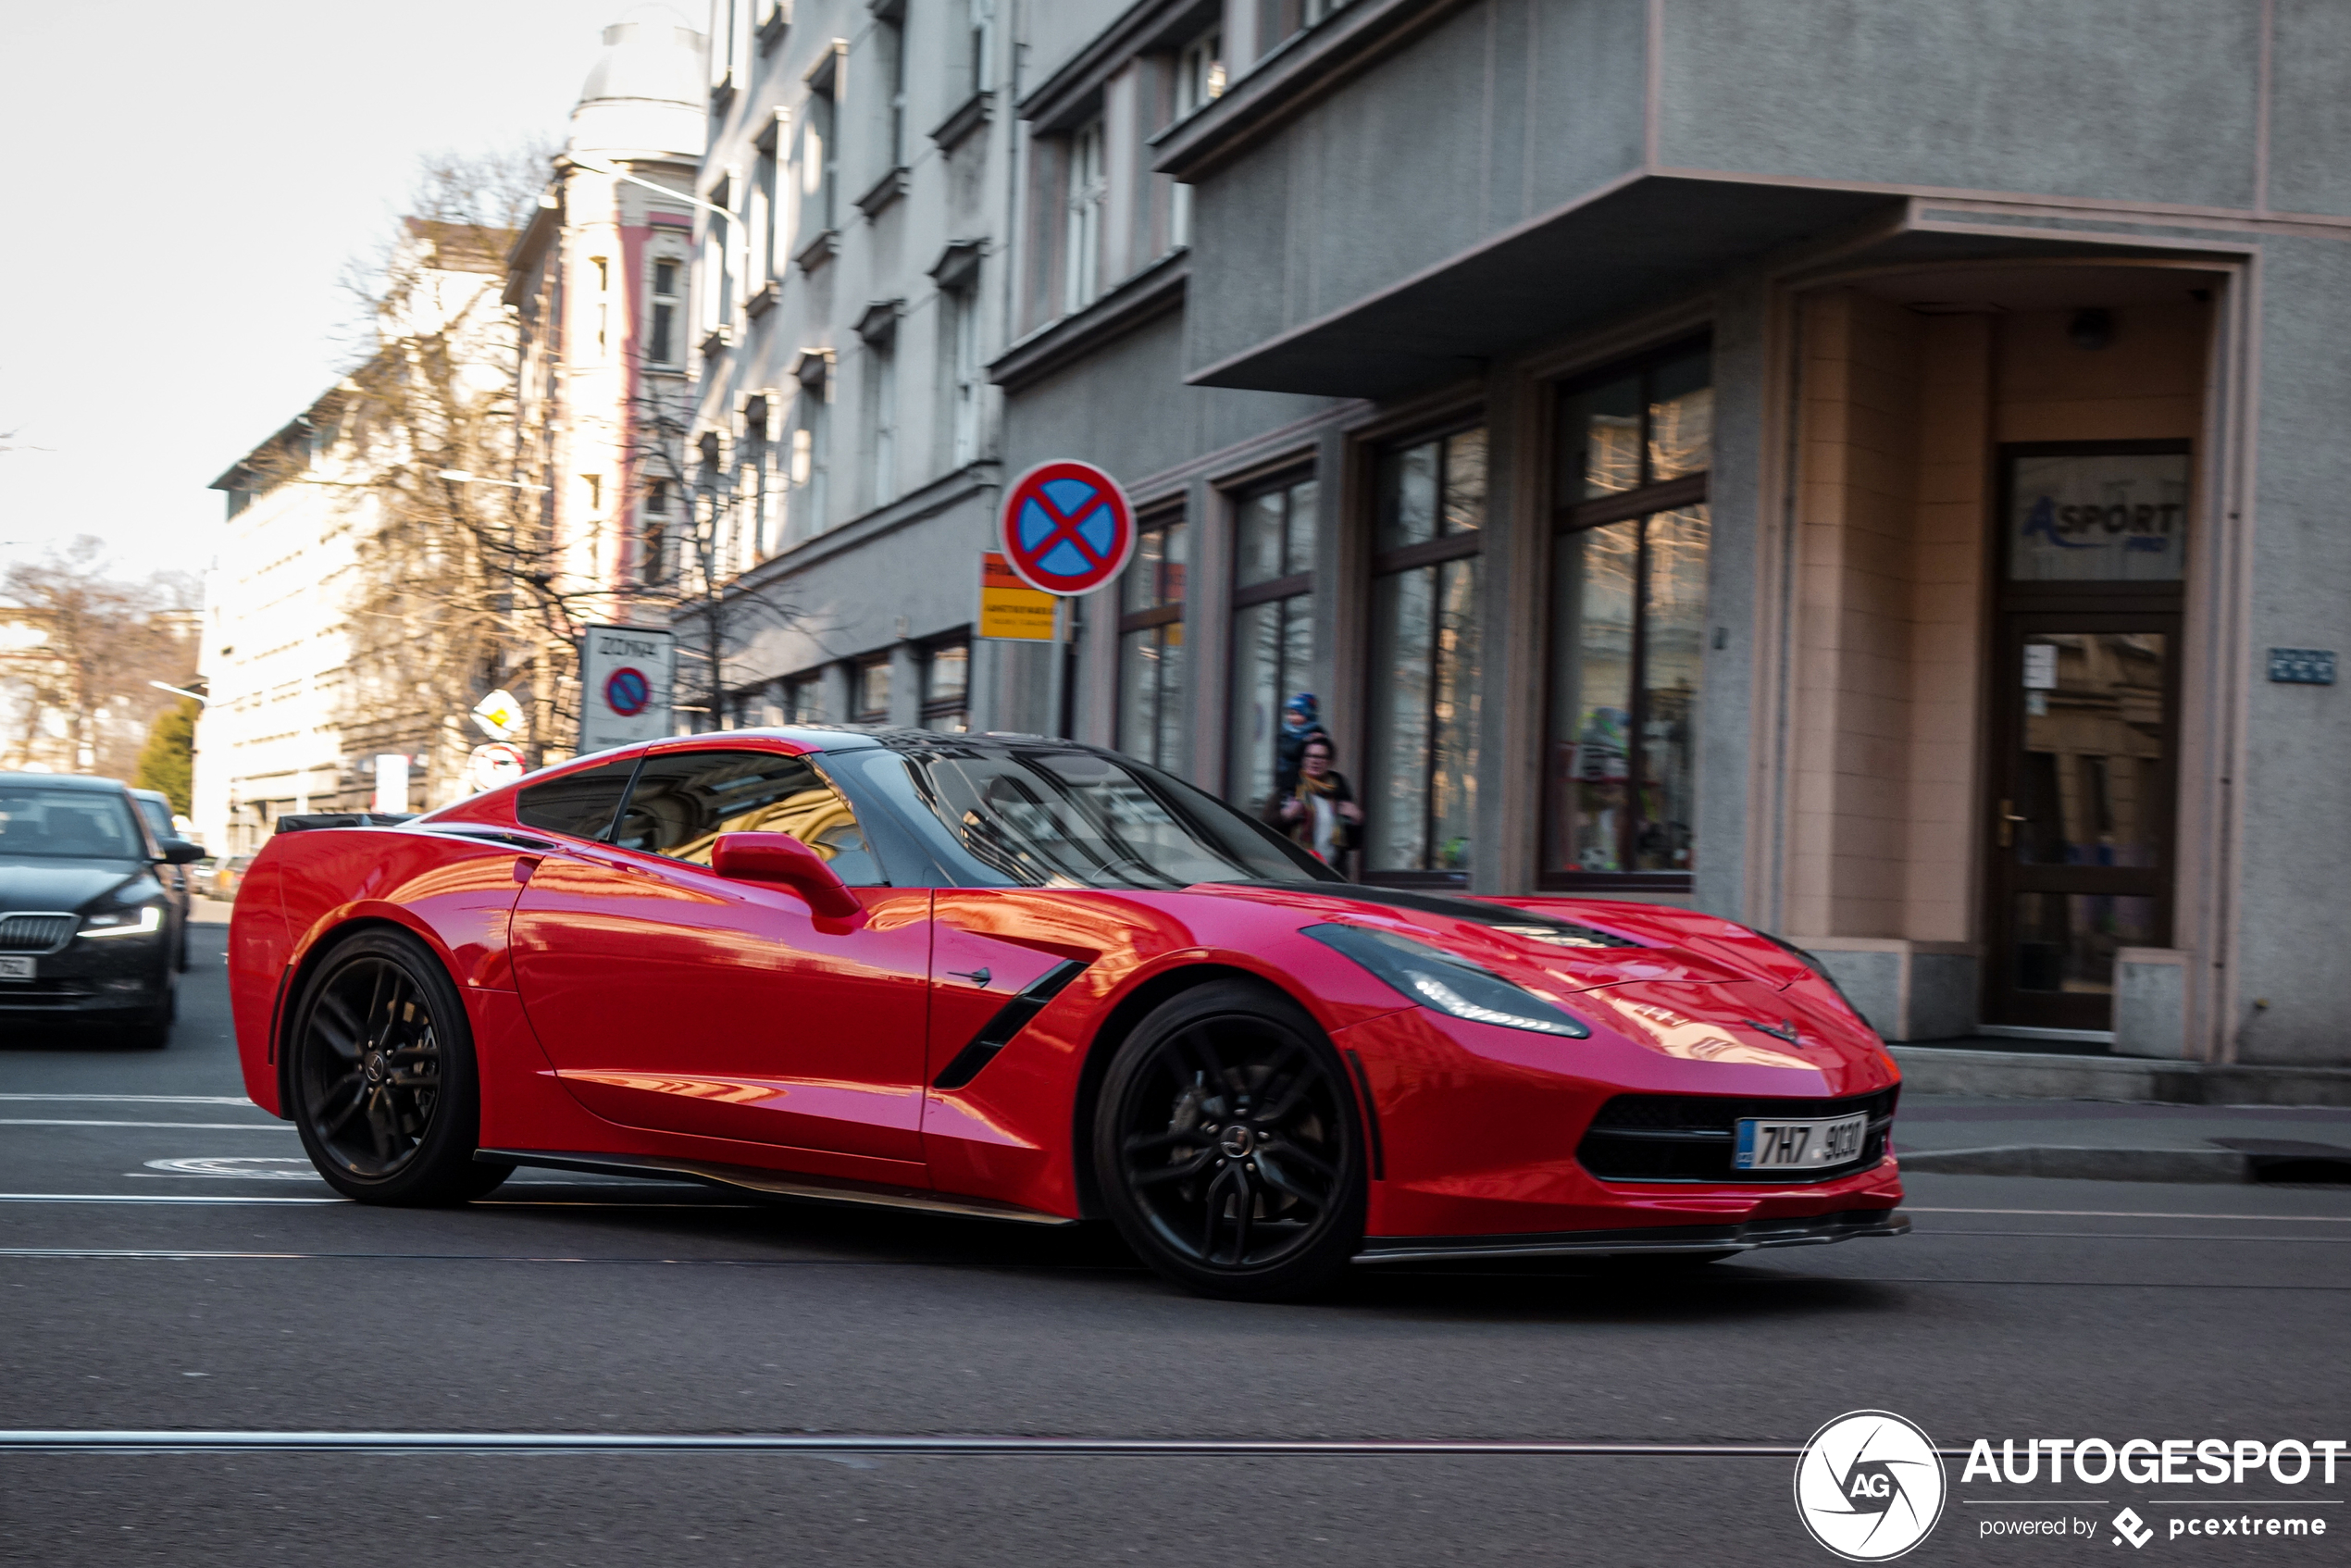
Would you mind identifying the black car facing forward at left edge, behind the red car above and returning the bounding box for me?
[0,774,205,1046]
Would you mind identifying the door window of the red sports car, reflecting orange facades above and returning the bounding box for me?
[614,750,889,886]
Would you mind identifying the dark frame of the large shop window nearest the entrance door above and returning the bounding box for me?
[1536,331,1714,893]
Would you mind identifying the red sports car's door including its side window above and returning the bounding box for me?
[513,743,931,1180]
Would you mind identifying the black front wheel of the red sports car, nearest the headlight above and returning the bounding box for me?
[1093,980,1363,1300]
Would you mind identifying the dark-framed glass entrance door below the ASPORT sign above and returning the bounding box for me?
[1984,614,2180,1029]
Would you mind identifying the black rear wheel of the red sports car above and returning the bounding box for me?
[287,928,510,1203]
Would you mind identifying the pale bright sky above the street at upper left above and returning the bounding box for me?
[0,0,672,576]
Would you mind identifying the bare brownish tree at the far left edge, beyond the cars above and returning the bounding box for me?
[0,534,197,778]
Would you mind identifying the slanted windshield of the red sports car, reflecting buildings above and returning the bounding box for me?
[826,738,1337,889]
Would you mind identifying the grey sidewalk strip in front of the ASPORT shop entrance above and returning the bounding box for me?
[1895,1089,2351,1182]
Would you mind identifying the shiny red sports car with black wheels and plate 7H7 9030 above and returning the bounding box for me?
[230,727,1909,1298]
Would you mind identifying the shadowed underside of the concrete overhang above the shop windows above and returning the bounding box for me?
[1185,174,2226,400]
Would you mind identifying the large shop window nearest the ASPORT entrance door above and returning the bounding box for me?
[1537,345,1714,886]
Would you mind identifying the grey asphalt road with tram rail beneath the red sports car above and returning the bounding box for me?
[0,927,2351,1568]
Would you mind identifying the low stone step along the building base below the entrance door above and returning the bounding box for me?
[1885,1046,2351,1107]
